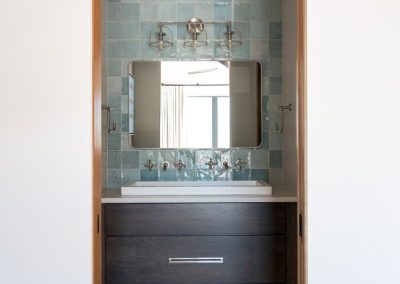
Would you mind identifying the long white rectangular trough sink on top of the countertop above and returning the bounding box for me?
[121,180,272,196]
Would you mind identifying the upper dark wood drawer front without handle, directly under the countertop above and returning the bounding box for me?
[104,203,286,236]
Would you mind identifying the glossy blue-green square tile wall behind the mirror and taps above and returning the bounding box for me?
[103,0,283,188]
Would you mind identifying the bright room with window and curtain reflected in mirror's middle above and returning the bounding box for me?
[160,61,230,148]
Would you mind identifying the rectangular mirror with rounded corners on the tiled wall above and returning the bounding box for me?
[128,61,262,149]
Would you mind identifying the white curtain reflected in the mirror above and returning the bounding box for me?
[160,86,185,148]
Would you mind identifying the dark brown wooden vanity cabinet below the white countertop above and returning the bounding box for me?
[103,203,297,284]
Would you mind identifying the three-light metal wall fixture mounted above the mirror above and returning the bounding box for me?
[149,17,242,51]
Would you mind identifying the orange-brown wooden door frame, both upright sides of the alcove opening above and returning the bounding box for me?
[92,0,308,284]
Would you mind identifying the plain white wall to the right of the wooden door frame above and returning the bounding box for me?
[308,0,400,284]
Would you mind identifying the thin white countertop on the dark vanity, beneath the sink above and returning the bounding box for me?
[101,188,297,203]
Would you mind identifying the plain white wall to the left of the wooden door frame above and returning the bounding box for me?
[0,0,92,284]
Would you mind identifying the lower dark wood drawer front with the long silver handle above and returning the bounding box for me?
[105,236,286,284]
